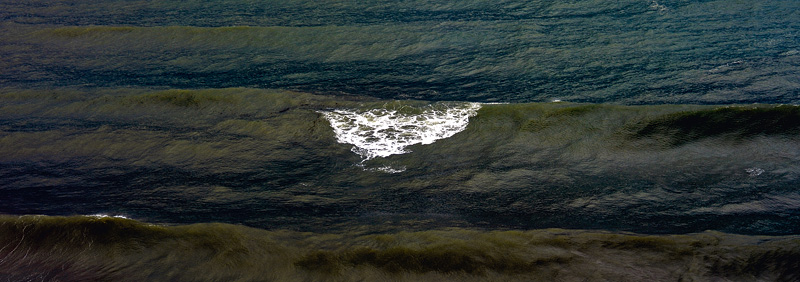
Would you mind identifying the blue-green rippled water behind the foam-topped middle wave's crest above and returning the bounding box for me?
[0,0,800,104]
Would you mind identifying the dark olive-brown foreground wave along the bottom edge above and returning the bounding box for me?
[0,216,800,281]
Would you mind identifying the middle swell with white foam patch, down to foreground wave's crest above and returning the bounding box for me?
[0,88,800,235]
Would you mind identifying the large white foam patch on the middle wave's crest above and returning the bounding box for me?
[321,103,481,161]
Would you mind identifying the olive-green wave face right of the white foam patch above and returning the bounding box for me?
[474,103,800,147]
